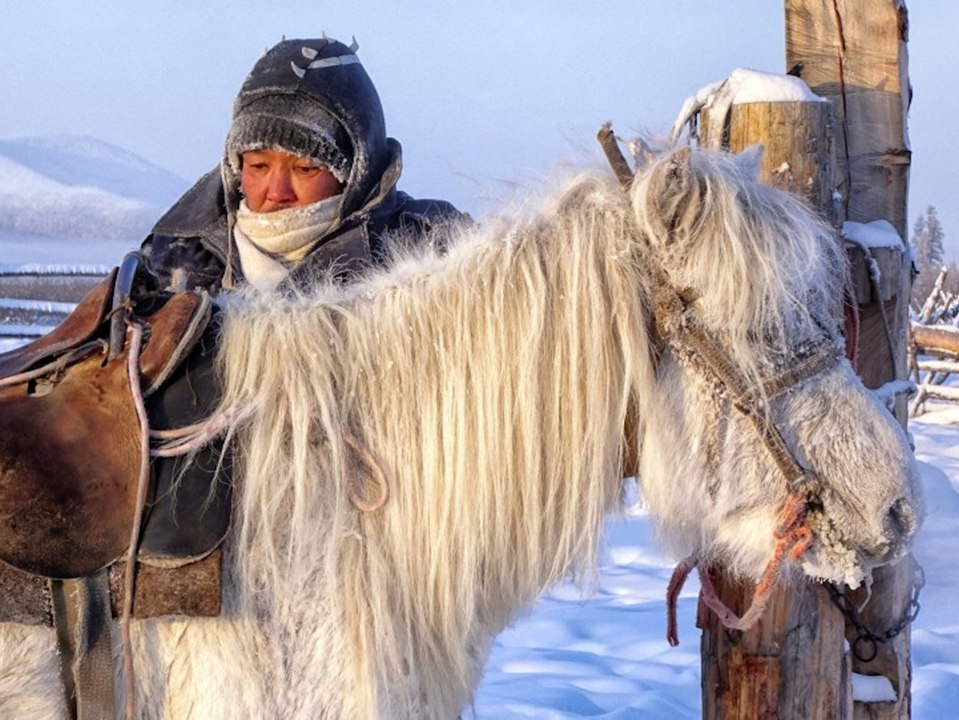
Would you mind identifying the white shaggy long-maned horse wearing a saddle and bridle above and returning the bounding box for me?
[0,145,921,720]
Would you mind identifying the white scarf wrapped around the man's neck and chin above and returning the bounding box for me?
[233,195,343,292]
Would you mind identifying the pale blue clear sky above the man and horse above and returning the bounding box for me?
[0,0,959,258]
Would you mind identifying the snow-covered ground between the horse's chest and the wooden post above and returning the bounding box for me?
[464,490,700,720]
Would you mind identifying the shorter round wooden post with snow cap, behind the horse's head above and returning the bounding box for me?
[700,97,852,720]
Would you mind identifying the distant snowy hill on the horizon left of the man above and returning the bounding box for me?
[0,135,190,250]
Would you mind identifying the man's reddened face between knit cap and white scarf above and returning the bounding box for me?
[240,150,343,212]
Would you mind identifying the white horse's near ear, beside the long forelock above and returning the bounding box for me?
[646,146,701,250]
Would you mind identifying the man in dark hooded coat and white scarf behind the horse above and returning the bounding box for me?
[141,37,466,292]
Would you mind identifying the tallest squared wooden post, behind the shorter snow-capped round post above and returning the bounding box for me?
[785,0,913,719]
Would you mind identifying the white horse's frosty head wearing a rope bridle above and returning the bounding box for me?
[632,149,922,586]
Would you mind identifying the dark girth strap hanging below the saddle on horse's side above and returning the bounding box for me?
[49,570,116,720]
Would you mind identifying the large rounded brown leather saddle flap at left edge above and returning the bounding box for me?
[0,352,140,578]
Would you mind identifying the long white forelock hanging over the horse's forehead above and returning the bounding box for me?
[633,151,845,372]
